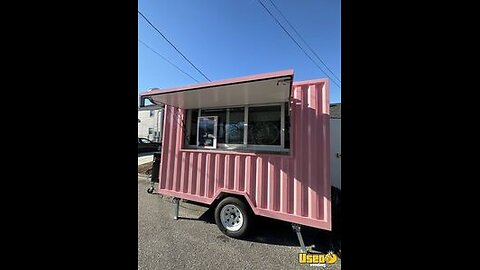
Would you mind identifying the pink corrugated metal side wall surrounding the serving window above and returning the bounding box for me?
[159,80,331,230]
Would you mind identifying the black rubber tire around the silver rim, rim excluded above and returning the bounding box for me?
[215,197,253,238]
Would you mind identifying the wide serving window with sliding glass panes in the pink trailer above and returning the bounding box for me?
[185,103,290,152]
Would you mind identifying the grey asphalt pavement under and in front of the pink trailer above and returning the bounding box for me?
[138,175,341,269]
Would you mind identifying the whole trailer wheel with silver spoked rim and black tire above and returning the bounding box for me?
[215,197,252,238]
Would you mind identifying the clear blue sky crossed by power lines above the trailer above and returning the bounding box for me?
[137,0,341,103]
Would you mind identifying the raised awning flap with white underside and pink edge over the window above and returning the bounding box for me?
[142,71,293,109]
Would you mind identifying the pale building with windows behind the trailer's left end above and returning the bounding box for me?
[138,106,163,142]
